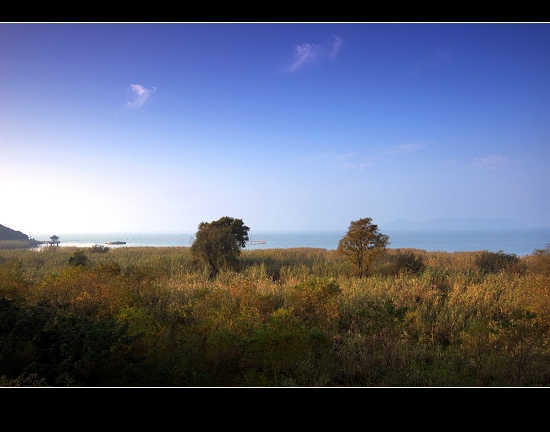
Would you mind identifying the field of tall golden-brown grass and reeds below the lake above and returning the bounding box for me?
[0,247,550,387]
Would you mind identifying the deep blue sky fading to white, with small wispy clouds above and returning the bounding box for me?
[0,22,550,236]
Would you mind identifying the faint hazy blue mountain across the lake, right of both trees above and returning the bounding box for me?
[380,218,528,230]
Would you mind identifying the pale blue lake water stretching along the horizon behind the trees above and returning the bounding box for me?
[31,228,550,256]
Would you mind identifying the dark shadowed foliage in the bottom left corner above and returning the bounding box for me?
[0,299,144,387]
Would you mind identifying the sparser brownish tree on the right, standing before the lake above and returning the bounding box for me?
[337,218,389,278]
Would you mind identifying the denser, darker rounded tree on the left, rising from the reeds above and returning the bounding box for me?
[191,216,250,277]
